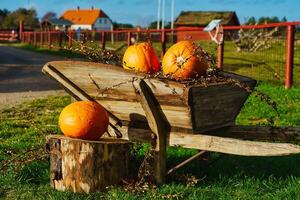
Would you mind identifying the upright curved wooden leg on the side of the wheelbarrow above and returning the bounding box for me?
[137,80,170,184]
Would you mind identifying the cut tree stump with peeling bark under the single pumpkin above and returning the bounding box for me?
[47,135,129,193]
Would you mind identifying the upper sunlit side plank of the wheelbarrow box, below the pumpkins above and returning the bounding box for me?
[49,62,187,106]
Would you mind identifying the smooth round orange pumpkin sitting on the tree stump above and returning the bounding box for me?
[59,101,109,140]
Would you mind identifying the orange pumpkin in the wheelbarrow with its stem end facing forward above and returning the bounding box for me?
[162,41,209,80]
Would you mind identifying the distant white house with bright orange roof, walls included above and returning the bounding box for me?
[60,7,113,30]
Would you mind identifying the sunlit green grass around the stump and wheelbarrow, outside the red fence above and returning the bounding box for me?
[0,83,300,200]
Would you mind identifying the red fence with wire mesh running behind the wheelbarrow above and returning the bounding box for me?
[21,22,300,88]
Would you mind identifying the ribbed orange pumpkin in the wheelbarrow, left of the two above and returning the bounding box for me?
[123,42,160,73]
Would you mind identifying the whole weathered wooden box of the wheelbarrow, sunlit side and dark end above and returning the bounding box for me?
[43,61,255,132]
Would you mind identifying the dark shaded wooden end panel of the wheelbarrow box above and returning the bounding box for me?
[189,85,249,132]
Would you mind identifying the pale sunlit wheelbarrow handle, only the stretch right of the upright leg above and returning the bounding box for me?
[169,133,300,156]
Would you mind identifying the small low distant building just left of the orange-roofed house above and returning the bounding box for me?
[41,18,72,31]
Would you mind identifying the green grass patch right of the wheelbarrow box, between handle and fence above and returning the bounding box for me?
[237,82,300,126]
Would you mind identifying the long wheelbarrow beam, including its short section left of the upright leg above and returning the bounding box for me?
[103,126,300,156]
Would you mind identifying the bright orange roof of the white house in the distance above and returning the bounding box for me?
[61,9,108,25]
